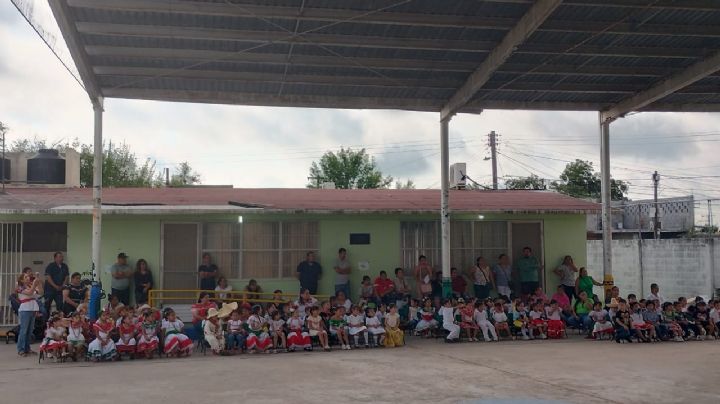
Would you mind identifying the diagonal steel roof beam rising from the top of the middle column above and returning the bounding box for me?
[440,0,562,121]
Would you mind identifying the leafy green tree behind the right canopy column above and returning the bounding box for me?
[550,159,629,201]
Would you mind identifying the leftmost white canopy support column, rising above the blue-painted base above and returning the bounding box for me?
[92,98,103,281]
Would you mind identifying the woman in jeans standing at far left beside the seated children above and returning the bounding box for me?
[16,273,43,356]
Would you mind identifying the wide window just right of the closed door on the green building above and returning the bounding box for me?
[202,221,320,279]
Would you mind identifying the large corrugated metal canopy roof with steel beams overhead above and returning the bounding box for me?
[50,0,720,120]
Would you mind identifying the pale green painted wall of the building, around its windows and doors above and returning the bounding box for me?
[4,214,587,304]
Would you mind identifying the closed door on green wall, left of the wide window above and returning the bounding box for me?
[162,223,200,289]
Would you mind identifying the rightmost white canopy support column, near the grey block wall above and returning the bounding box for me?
[598,113,613,298]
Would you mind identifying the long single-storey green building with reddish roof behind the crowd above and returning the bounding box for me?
[0,187,598,322]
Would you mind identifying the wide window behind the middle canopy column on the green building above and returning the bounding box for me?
[400,220,508,270]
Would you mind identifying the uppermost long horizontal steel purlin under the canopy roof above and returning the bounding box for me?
[68,0,720,37]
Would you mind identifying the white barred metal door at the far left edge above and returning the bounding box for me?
[0,223,23,326]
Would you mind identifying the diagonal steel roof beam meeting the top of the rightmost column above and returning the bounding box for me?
[601,52,720,122]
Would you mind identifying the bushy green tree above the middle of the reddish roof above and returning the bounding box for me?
[307,148,393,189]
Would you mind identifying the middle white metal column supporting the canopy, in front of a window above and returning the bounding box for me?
[440,118,452,297]
